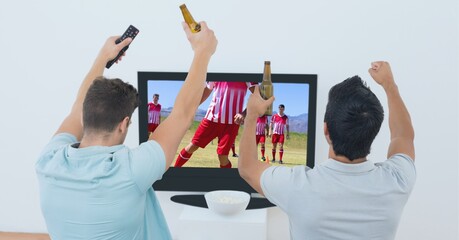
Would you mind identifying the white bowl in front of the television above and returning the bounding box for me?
[204,190,250,215]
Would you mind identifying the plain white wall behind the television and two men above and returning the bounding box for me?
[0,0,459,239]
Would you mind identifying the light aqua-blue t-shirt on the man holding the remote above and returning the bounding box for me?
[35,133,172,240]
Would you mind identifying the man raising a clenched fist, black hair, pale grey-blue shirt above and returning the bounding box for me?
[238,62,416,240]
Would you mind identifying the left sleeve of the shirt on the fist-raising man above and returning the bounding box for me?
[260,166,293,210]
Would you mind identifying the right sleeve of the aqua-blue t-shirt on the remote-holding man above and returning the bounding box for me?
[129,140,166,191]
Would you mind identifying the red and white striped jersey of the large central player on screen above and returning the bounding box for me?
[204,82,257,124]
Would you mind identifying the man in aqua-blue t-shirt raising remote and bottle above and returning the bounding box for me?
[36,22,217,240]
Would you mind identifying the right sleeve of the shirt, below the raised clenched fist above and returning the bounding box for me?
[379,154,416,191]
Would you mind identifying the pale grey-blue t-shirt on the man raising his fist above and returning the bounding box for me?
[260,154,416,240]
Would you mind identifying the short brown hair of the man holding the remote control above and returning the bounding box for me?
[83,77,139,132]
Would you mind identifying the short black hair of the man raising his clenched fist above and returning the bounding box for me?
[324,76,384,161]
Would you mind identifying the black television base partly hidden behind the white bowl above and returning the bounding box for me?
[171,194,275,209]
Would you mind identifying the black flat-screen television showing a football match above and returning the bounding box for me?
[137,71,317,209]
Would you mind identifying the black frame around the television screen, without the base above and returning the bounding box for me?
[137,71,317,193]
